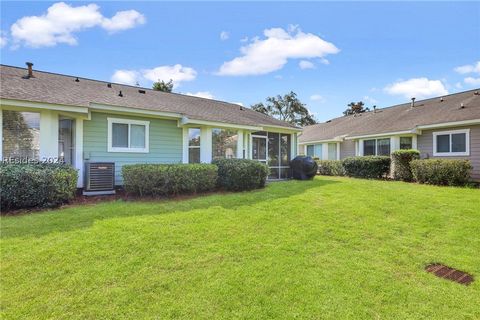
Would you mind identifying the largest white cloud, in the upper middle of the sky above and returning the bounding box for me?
[217,26,340,76]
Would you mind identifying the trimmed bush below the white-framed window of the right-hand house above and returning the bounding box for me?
[410,159,472,186]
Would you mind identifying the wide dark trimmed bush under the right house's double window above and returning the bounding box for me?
[343,156,390,179]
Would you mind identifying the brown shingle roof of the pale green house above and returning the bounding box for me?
[0,65,296,128]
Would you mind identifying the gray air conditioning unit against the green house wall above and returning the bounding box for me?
[83,162,115,196]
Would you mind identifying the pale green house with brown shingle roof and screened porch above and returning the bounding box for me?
[0,65,301,187]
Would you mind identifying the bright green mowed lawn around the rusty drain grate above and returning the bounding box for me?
[0,177,480,319]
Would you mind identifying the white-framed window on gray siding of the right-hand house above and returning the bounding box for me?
[433,129,470,156]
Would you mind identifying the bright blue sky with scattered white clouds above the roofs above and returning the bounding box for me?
[0,1,480,121]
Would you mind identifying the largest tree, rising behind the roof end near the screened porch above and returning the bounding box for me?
[250,91,316,126]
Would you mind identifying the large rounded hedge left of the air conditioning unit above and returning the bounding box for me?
[0,163,78,210]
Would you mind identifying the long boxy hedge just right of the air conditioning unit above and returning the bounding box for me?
[122,163,217,196]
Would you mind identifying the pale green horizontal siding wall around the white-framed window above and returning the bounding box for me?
[83,112,182,185]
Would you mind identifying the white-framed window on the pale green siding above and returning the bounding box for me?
[107,118,150,153]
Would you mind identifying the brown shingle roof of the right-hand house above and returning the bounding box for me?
[299,89,480,143]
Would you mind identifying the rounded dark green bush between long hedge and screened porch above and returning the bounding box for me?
[213,159,269,191]
